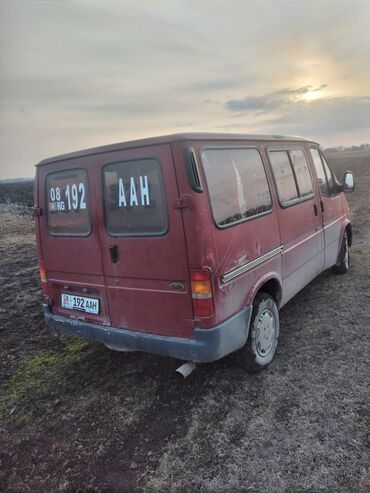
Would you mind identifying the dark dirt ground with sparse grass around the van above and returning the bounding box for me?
[0,152,370,493]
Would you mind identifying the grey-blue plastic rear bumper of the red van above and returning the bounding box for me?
[43,305,252,363]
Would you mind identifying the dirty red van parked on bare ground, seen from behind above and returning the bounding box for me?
[35,133,354,367]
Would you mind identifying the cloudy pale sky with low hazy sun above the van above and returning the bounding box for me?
[0,0,370,179]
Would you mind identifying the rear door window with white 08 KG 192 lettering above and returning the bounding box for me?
[46,169,91,236]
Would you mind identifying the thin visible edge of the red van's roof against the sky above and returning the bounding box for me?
[36,132,318,166]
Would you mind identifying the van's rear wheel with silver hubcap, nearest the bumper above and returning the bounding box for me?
[230,292,280,373]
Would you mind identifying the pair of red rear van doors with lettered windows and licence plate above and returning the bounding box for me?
[36,145,194,338]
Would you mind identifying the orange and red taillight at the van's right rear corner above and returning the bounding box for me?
[190,269,213,318]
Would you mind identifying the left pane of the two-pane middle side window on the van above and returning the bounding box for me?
[269,151,299,205]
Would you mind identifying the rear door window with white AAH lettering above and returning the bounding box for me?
[103,159,167,236]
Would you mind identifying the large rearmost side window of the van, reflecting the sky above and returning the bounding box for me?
[201,149,272,226]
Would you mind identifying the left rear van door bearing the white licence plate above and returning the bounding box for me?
[36,158,110,325]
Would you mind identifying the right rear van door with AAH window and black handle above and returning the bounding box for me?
[97,145,193,337]
